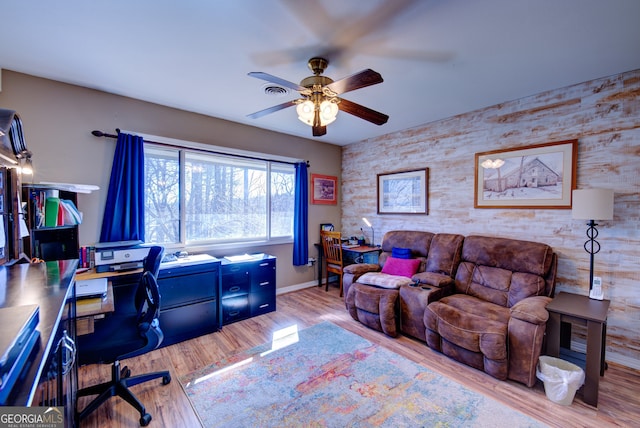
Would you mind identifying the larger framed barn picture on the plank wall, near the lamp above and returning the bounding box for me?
[474,140,578,209]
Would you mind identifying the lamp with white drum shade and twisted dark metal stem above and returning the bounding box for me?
[571,189,613,299]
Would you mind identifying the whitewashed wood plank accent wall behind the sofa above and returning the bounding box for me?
[342,70,640,369]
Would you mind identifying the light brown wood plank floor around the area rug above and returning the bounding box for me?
[79,287,640,428]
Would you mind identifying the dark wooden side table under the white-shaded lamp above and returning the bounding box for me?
[547,292,611,407]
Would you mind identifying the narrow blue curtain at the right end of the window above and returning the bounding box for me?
[293,162,309,266]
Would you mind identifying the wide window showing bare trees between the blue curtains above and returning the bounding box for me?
[145,144,295,245]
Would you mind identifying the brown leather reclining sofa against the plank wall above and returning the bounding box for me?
[343,231,557,387]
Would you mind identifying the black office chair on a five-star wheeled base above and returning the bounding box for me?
[78,246,171,426]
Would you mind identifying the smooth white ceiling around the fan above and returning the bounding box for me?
[0,0,640,145]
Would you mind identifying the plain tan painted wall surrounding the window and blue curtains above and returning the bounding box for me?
[0,70,341,288]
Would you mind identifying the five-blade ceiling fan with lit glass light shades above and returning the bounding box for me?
[247,57,389,137]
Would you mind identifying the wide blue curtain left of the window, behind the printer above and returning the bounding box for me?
[100,133,144,242]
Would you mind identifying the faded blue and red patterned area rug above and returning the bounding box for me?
[180,322,545,428]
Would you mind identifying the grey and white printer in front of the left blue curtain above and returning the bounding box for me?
[95,241,149,272]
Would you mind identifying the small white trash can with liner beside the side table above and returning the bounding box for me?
[536,355,584,406]
